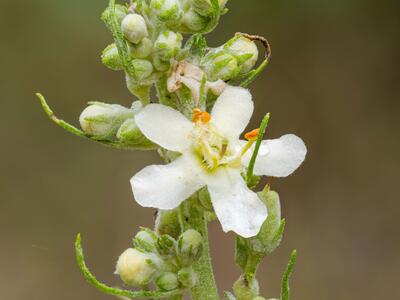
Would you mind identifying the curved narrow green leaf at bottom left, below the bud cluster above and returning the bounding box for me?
[75,234,182,299]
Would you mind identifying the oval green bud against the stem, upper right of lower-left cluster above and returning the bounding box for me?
[178,229,203,264]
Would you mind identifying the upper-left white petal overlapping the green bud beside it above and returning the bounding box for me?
[135,104,193,152]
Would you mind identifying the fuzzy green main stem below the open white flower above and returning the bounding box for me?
[186,198,219,300]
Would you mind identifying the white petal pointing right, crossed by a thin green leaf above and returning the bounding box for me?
[243,134,307,177]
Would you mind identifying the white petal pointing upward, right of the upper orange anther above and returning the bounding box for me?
[211,86,254,138]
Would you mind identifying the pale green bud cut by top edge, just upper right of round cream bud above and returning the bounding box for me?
[151,0,183,26]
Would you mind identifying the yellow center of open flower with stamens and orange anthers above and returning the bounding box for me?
[190,108,259,172]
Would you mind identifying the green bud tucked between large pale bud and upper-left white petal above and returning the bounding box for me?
[117,118,157,150]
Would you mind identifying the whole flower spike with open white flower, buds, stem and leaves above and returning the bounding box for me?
[38,0,307,300]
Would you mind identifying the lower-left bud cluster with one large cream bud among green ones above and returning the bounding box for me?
[115,228,203,291]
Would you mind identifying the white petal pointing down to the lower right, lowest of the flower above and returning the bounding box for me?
[207,168,268,238]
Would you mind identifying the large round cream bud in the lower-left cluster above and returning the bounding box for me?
[115,248,162,286]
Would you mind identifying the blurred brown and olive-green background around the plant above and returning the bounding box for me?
[0,0,400,300]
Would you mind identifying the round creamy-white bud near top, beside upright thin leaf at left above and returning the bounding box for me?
[121,14,149,44]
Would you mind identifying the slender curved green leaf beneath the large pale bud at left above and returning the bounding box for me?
[36,93,151,150]
